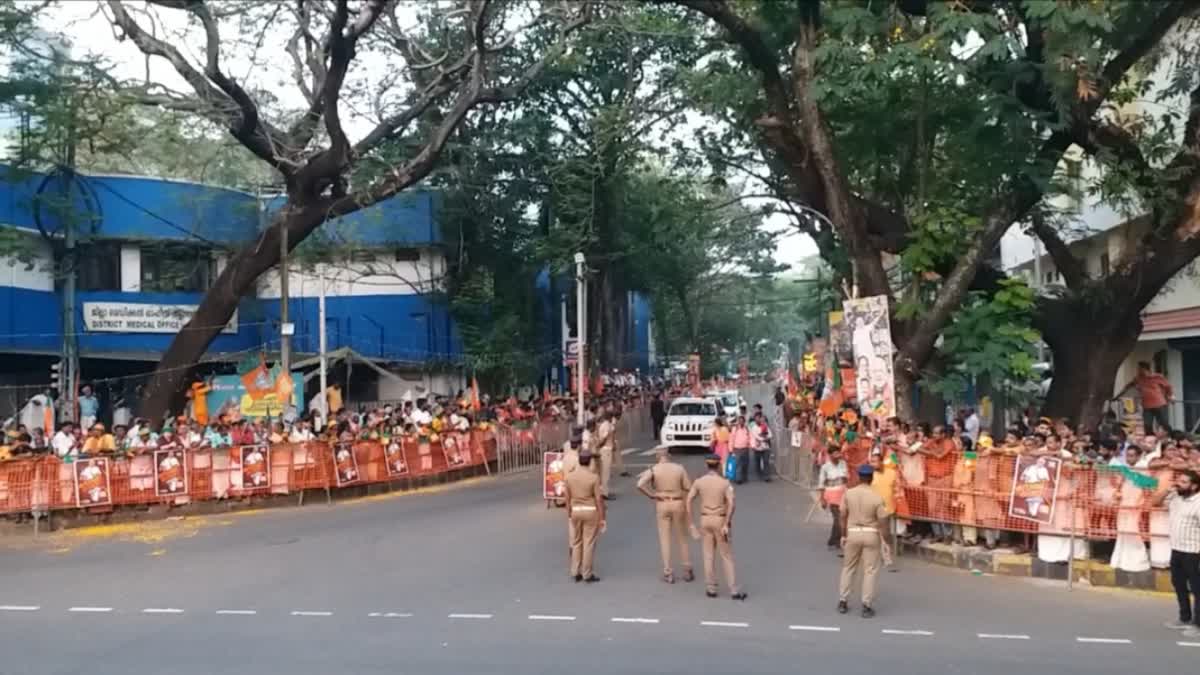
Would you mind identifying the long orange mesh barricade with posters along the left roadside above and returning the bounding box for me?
[0,429,498,514]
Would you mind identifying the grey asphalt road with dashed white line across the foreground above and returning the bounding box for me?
[0,396,1200,675]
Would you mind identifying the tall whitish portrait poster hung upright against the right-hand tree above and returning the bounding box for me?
[842,295,896,420]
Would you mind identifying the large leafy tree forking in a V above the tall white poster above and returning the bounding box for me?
[677,0,1196,414]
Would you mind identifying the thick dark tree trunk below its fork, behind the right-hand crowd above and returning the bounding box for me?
[1038,299,1141,430]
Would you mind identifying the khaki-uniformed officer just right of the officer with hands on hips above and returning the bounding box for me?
[684,455,746,601]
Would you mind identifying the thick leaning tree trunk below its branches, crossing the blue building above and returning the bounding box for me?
[138,205,328,420]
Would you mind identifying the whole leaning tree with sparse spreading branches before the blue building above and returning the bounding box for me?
[76,0,590,417]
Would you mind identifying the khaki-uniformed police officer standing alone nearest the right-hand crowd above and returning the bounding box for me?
[838,464,888,619]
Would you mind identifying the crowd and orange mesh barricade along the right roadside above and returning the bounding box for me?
[786,374,1200,637]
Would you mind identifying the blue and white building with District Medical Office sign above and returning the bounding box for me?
[0,166,463,419]
